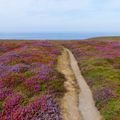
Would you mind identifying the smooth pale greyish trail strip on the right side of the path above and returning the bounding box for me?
[65,49,102,120]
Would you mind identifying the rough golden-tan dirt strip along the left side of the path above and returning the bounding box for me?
[57,49,82,120]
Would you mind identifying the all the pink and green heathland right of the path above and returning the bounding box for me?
[63,38,120,120]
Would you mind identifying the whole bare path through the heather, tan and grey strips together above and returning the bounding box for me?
[57,48,102,120]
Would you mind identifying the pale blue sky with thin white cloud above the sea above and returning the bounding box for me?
[0,0,120,33]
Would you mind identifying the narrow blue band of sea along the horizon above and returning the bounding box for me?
[0,33,120,40]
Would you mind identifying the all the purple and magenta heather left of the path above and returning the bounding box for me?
[0,41,63,120]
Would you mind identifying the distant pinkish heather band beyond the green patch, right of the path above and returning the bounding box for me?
[66,40,120,58]
